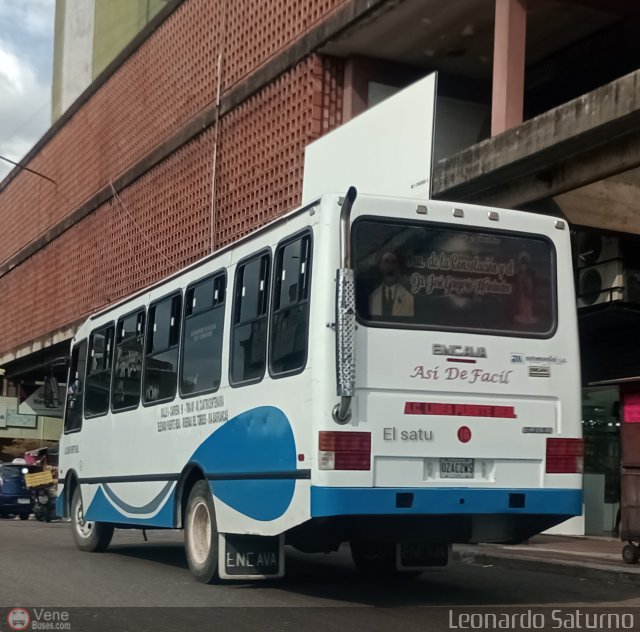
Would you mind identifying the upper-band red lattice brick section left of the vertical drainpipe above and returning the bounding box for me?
[0,0,222,261]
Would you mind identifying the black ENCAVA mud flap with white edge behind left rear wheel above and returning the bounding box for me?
[218,533,284,580]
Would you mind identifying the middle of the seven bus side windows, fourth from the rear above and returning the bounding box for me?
[143,294,182,403]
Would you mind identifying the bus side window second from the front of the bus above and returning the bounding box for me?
[84,325,114,417]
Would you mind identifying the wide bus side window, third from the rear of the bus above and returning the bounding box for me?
[180,273,227,395]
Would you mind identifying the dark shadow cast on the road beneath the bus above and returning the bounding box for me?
[91,538,637,607]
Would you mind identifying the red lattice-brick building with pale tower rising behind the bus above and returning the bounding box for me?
[0,0,640,532]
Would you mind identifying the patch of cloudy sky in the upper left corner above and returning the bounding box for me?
[0,0,56,180]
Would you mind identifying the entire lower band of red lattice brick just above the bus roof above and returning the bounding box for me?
[0,50,343,353]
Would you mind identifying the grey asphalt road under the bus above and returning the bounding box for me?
[0,520,640,632]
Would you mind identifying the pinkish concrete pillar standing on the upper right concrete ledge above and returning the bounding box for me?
[491,0,527,136]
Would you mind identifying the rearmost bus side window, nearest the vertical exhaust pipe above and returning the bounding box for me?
[269,235,311,376]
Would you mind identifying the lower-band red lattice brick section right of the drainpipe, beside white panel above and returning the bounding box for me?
[215,57,342,247]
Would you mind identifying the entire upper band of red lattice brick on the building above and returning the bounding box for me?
[0,0,348,263]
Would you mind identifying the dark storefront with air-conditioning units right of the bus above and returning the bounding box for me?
[574,227,640,535]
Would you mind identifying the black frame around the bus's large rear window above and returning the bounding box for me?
[350,215,559,340]
